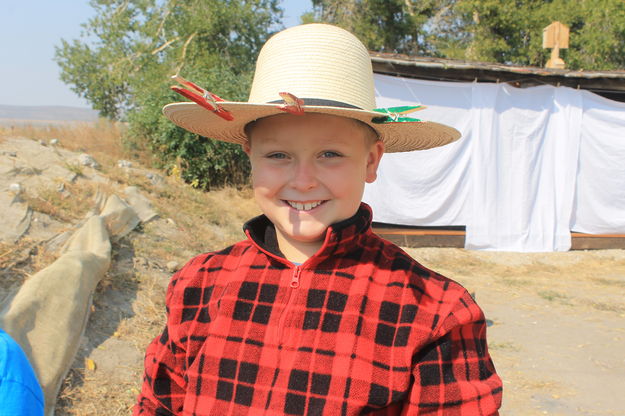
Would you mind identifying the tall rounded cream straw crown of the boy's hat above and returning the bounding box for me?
[248,23,375,110]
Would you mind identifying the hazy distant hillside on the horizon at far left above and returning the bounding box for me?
[0,104,98,122]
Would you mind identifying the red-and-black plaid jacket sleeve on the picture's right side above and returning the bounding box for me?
[402,290,502,416]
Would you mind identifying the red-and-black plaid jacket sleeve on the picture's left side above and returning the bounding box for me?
[133,270,186,416]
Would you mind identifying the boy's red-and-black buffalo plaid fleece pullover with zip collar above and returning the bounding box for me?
[134,204,502,416]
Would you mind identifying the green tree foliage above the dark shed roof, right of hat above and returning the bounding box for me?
[302,0,625,70]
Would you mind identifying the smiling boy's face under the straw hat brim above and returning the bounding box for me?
[244,113,384,248]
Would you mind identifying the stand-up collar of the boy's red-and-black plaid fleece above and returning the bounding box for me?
[243,202,373,266]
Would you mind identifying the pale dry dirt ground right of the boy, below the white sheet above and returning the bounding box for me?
[408,248,625,416]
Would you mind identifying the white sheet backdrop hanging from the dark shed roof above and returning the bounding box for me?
[364,74,625,252]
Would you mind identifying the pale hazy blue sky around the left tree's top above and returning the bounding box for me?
[0,0,312,107]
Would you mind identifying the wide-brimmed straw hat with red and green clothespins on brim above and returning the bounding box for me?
[163,23,460,152]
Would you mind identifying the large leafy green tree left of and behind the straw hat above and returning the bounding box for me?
[56,0,282,188]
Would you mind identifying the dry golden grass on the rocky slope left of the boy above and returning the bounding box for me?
[0,120,259,416]
